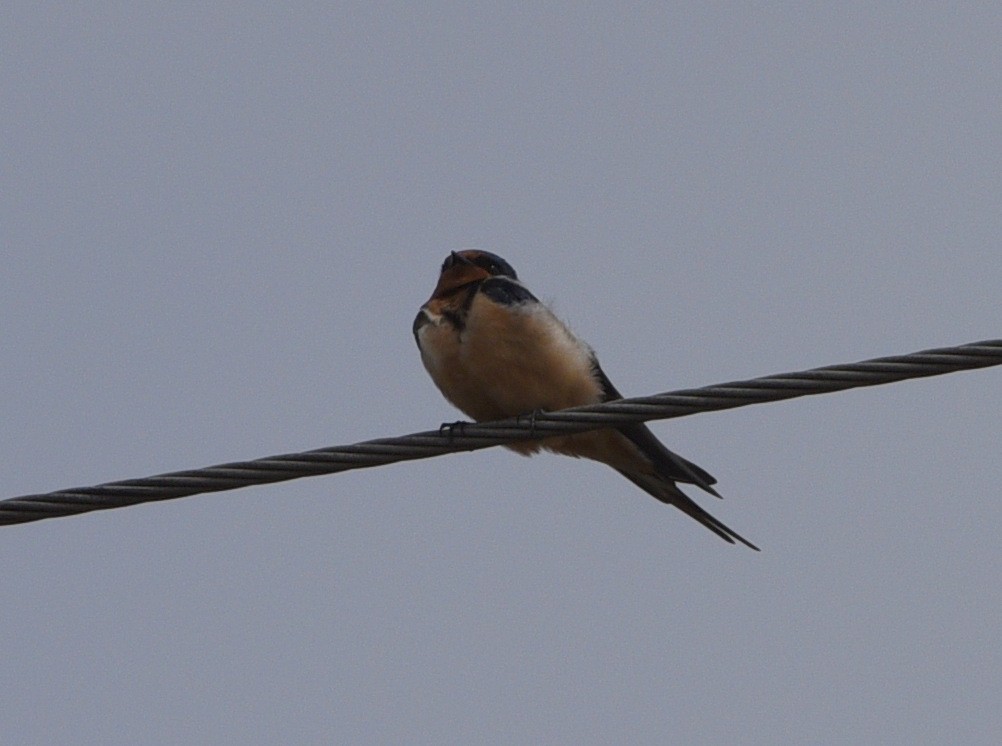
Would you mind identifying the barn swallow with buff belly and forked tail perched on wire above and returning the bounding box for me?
[414,250,759,551]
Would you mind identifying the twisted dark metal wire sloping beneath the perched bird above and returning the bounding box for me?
[0,339,1002,526]
